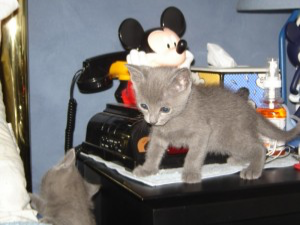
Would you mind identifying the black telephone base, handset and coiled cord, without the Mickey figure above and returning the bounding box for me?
[65,49,192,169]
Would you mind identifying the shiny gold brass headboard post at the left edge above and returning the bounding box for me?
[0,0,32,191]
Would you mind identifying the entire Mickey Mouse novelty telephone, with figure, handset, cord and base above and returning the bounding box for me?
[65,7,224,169]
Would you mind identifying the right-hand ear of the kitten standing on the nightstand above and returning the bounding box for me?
[170,68,192,93]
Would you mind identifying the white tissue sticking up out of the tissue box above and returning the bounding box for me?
[207,43,237,68]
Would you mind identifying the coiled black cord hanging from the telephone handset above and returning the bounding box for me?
[65,69,83,151]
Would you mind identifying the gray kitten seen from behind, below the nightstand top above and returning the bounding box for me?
[30,149,99,225]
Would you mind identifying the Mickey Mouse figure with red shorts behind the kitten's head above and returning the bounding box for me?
[113,7,199,104]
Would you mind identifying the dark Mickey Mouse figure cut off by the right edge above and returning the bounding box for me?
[286,16,300,118]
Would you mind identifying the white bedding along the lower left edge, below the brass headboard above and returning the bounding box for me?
[0,83,37,223]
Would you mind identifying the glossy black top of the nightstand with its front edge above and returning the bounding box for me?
[77,153,300,206]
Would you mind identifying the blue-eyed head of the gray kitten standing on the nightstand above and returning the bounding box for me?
[128,65,191,126]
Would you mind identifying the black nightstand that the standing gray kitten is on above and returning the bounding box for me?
[77,153,300,225]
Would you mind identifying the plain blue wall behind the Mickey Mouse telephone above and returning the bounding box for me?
[28,0,293,192]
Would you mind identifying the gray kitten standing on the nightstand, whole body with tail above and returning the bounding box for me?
[128,65,300,183]
